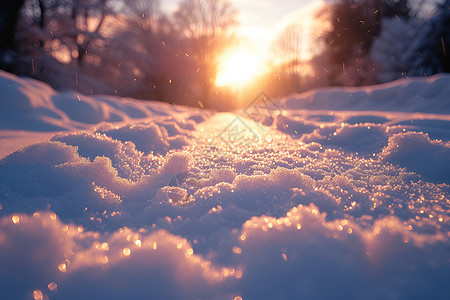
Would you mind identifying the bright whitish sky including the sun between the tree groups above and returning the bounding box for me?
[161,0,324,81]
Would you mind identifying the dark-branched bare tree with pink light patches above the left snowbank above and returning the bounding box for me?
[12,0,114,93]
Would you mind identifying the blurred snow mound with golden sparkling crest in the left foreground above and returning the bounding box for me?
[0,212,237,299]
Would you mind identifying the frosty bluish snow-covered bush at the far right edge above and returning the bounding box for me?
[371,0,450,82]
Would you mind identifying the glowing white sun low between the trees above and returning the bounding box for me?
[215,50,260,87]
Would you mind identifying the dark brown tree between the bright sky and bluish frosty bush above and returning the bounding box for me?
[325,0,412,85]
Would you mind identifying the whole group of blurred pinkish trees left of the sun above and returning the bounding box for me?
[0,0,236,105]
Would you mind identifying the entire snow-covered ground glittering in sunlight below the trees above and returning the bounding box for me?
[0,72,450,299]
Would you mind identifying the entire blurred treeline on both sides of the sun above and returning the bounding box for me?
[0,0,450,107]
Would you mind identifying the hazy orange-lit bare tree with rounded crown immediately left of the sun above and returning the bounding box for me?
[175,0,237,106]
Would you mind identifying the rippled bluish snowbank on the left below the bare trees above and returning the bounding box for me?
[0,70,204,131]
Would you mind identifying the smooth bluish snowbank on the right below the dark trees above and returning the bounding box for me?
[281,74,450,114]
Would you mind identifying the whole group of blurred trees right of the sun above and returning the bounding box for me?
[266,0,450,95]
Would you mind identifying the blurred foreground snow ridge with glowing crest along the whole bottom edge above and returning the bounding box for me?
[0,205,450,299]
